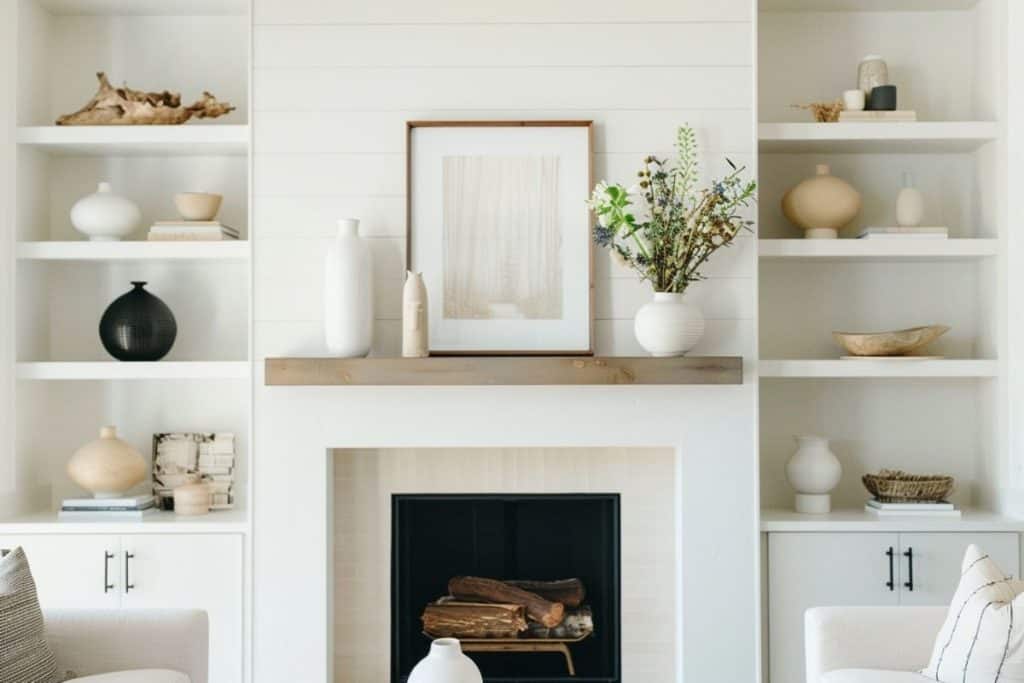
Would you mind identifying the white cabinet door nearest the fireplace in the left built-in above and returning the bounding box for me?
[119,533,244,683]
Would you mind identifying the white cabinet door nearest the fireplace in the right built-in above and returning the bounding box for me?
[768,533,899,683]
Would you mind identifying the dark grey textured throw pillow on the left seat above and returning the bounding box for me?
[0,548,63,683]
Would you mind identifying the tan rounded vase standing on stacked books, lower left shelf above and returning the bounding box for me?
[68,427,145,498]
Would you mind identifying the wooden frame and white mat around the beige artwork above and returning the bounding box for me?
[406,121,594,355]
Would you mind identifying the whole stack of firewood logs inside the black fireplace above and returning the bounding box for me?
[422,577,594,639]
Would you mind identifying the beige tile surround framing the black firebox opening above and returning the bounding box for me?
[334,447,681,683]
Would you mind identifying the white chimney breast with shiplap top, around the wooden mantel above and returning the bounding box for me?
[252,0,758,683]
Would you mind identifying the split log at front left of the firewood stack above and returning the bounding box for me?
[421,600,526,638]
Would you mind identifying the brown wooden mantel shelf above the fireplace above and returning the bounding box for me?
[265,356,743,386]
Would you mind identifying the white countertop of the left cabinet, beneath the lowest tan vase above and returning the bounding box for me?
[0,509,249,535]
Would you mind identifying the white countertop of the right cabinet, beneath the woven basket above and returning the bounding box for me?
[761,508,1024,532]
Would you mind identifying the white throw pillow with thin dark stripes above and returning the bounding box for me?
[921,546,1024,683]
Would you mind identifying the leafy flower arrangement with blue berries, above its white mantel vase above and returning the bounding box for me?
[588,126,757,294]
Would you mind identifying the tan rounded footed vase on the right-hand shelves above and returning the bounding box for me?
[782,164,860,240]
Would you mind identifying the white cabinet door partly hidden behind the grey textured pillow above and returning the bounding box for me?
[0,533,121,609]
